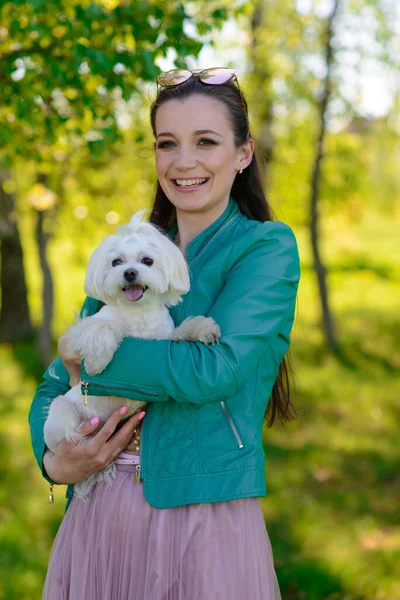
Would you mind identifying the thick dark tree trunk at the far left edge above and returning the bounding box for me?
[0,171,34,343]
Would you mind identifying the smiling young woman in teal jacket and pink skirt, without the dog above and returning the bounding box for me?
[30,68,300,600]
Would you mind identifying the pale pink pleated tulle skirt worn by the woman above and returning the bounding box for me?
[43,465,281,600]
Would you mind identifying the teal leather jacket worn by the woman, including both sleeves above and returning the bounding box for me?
[29,199,300,508]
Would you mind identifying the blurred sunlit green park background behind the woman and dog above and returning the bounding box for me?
[0,0,400,600]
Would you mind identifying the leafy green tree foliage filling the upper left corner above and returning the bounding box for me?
[0,0,231,164]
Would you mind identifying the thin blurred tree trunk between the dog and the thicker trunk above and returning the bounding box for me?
[36,175,54,366]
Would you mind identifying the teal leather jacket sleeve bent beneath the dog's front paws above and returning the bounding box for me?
[82,221,300,405]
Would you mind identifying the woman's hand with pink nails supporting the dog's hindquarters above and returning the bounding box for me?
[43,406,144,484]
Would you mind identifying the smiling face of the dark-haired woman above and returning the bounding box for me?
[155,95,251,220]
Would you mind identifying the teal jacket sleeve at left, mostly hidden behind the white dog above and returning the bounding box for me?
[29,298,97,483]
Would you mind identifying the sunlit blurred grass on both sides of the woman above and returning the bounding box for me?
[0,209,400,600]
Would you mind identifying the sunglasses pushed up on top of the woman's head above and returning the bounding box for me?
[156,67,247,134]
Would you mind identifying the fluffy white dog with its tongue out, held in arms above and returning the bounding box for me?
[44,212,221,500]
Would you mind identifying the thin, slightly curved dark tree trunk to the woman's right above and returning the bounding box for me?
[310,0,339,354]
